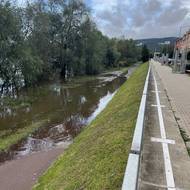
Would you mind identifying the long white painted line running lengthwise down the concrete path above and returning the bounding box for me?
[153,70,176,190]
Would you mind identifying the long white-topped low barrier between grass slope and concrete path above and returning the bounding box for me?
[122,65,150,190]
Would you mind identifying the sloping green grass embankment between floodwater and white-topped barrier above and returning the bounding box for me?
[34,64,148,190]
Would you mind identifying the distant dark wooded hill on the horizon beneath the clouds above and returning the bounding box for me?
[135,37,177,51]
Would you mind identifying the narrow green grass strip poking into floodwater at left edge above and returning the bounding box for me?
[0,120,45,151]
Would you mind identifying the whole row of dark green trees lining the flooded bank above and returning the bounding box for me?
[0,0,148,95]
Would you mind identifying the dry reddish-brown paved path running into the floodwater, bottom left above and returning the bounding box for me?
[0,148,64,190]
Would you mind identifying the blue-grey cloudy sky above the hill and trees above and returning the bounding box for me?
[86,0,190,39]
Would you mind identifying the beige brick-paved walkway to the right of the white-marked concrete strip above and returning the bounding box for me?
[153,62,190,144]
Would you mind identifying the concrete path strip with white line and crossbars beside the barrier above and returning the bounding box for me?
[138,63,190,190]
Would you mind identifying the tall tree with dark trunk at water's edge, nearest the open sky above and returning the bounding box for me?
[48,0,88,78]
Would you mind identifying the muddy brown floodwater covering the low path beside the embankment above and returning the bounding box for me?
[0,68,134,163]
